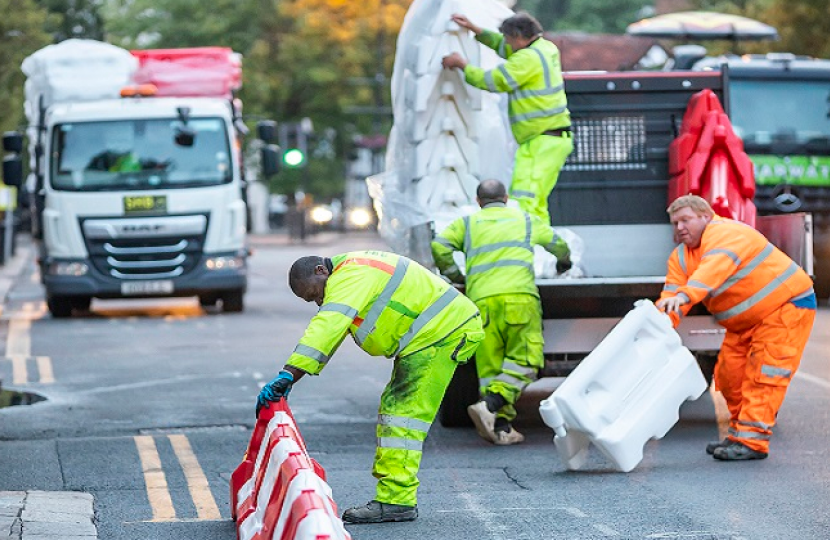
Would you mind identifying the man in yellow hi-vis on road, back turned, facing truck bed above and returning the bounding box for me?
[432,180,571,445]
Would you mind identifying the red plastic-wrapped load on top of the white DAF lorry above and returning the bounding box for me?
[130,47,242,98]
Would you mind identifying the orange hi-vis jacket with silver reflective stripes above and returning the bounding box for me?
[660,216,813,332]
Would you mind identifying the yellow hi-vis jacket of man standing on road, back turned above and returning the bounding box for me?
[432,203,570,302]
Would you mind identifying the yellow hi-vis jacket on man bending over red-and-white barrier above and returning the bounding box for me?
[286,251,478,375]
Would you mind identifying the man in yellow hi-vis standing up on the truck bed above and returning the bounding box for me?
[441,13,573,223]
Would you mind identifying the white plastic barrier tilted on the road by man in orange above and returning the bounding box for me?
[539,300,706,472]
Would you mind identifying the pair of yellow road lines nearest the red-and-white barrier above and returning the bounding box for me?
[134,434,222,522]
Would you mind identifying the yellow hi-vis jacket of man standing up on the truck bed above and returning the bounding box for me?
[464,30,571,144]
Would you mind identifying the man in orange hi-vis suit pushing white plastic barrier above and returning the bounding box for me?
[657,195,816,461]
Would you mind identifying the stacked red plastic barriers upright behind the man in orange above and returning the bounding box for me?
[668,89,756,227]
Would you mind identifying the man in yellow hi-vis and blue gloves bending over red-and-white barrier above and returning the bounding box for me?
[257,251,484,523]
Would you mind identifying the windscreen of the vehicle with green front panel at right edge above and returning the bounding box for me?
[729,79,830,145]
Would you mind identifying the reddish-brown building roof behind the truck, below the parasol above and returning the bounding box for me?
[545,32,668,71]
